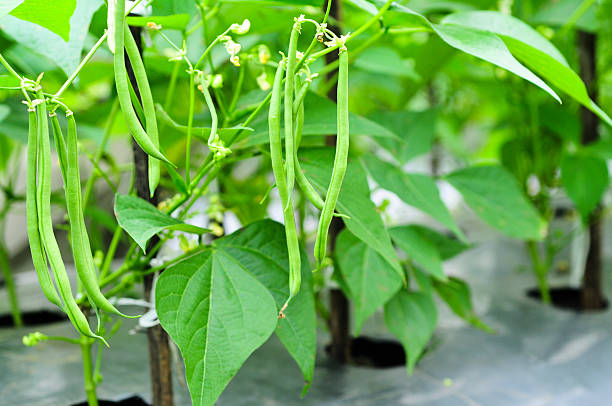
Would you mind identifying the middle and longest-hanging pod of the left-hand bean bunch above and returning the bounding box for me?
[36,95,108,345]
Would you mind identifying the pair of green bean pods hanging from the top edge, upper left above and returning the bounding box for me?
[113,1,172,196]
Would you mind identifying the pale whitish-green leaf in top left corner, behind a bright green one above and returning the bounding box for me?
[0,0,104,75]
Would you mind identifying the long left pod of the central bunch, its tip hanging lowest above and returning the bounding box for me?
[268,63,302,317]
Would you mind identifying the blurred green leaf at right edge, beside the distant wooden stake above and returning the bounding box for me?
[561,154,608,223]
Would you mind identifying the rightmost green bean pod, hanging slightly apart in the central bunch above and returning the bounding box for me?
[314,48,349,266]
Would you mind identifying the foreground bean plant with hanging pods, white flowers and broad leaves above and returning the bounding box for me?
[0,0,612,405]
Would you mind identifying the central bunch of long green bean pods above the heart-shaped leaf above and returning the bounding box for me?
[268,16,349,317]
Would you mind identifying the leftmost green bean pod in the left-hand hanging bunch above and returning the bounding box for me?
[26,108,64,309]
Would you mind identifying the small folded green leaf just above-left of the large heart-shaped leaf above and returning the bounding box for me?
[115,194,210,251]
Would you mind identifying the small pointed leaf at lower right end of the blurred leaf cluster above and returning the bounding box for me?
[434,276,493,333]
